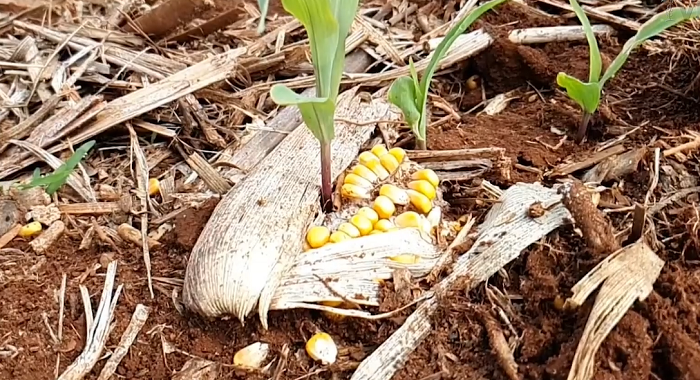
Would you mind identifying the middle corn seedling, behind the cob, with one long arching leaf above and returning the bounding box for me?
[388,0,508,150]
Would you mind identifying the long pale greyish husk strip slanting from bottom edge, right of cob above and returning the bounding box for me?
[351,183,569,380]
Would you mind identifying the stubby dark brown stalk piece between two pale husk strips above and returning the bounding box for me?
[562,181,621,254]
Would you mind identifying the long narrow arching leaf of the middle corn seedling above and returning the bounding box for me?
[418,0,508,140]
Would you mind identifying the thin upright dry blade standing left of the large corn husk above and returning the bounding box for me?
[127,124,155,298]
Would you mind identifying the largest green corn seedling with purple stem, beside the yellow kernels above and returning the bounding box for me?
[270,0,358,212]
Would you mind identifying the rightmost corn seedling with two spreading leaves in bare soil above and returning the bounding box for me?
[557,0,700,143]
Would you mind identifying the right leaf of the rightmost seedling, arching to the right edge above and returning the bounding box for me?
[600,7,700,89]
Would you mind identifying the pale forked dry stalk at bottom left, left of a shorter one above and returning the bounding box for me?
[58,261,122,380]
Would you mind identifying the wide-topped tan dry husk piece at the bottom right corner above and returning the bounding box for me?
[565,241,664,380]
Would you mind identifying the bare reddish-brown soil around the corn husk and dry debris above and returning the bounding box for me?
[0,3,700,380]
